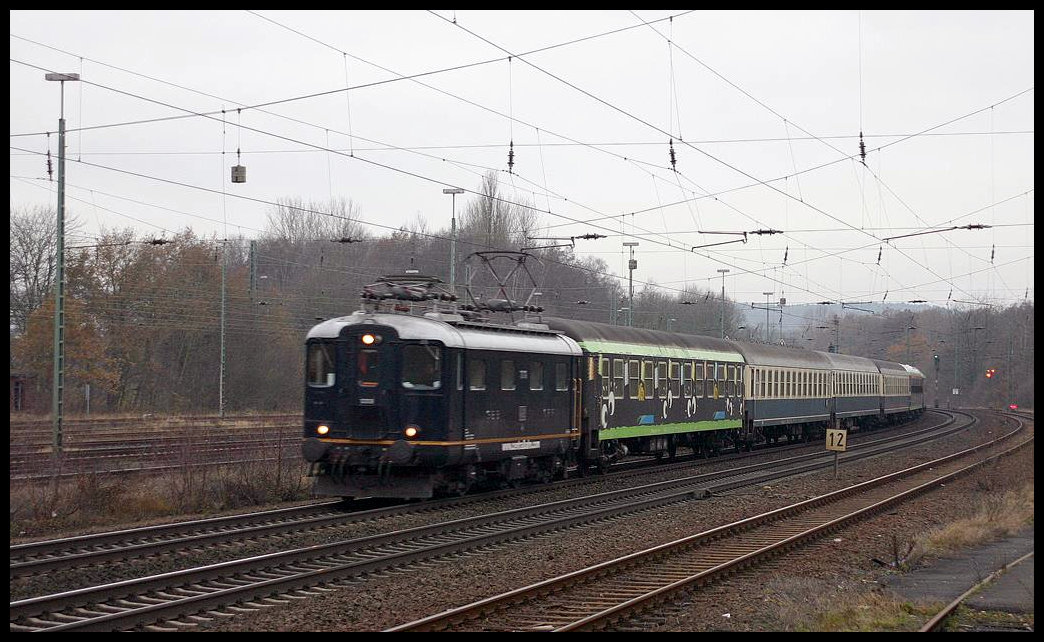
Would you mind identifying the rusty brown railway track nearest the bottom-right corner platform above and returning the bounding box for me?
[388,411,1033,632]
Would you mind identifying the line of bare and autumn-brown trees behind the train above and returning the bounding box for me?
[10,172,1033,414]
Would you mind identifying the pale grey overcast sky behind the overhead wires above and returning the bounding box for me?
[10,10,1035,305]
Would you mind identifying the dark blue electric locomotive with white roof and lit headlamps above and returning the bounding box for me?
[303,311,580,498]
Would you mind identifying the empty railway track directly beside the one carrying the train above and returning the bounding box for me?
[10,409,1002,631]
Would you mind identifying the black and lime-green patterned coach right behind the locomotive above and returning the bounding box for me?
[544,317,752,466]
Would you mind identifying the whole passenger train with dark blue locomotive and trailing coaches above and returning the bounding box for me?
[303,294,925,498]
